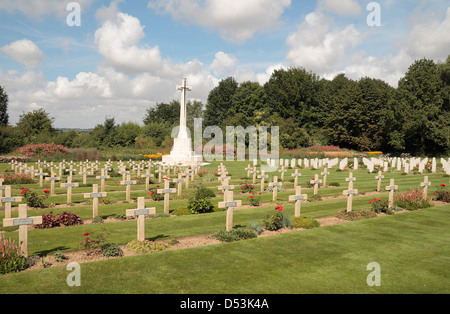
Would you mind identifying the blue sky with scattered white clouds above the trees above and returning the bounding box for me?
[0,0,450,128]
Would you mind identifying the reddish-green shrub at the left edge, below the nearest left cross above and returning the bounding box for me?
[0,234,28,274]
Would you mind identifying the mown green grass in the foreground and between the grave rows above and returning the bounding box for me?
[0,162,450,294]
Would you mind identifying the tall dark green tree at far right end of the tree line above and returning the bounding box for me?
[390,59,450,155]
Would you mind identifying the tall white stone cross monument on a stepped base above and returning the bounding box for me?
[162,78,203,165]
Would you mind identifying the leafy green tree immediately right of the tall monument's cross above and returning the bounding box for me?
[204,77,239,126]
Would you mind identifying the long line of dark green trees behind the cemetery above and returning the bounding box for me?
[0,56,450,156]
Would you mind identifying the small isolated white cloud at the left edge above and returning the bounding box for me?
[0,39,44,67]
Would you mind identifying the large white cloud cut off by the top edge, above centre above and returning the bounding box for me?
[148,0,291,43]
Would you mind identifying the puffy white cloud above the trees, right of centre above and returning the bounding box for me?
[286,12,362,75]
